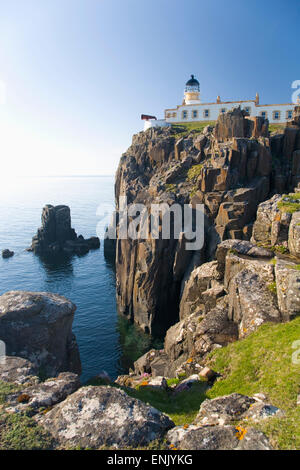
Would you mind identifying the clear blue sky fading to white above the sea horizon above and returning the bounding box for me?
[0,0,300,178]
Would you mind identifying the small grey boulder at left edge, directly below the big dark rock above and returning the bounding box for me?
[0,356,38,385]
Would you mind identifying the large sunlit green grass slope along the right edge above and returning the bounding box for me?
[207,317,300,449]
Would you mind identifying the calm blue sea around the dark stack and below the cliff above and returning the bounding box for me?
[0,176,160,381]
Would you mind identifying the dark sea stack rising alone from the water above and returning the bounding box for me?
[30,204,100,255]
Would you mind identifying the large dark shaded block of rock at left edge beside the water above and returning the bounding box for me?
[0,291,81,377]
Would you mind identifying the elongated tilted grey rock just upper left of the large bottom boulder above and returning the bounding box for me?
[6,372,80,414]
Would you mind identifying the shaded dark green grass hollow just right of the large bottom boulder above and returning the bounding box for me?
[125,382,207,426]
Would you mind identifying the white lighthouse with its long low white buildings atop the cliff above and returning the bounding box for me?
[144,75,299,130]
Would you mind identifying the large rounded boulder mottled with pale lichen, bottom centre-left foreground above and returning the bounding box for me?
[38,386,174,449]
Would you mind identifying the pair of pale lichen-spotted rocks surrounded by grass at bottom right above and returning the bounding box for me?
[167,393,284,450]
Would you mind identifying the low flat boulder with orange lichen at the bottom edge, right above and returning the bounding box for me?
[167,425,272,450]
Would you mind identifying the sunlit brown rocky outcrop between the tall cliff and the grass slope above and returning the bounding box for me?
[131,240,300,377]
